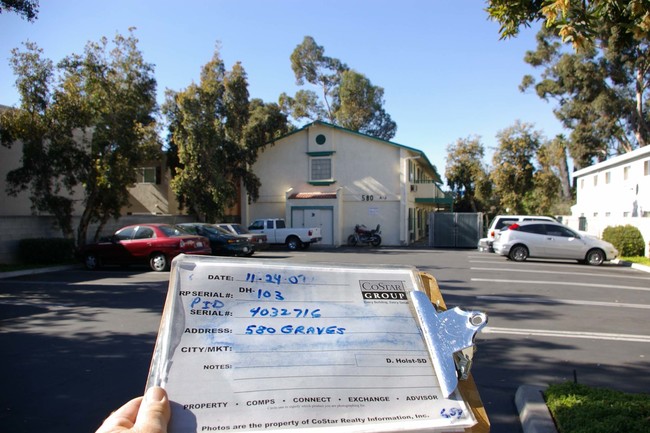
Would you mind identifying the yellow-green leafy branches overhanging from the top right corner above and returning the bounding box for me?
[486,0,650,49]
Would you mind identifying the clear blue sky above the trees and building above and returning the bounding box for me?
[0,0,563,182]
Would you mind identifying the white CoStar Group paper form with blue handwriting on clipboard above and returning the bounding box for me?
[148,256,475,433]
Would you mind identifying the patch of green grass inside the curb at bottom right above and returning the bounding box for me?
[544,382,650,433]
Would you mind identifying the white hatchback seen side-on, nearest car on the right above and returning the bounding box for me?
[493,221,618,265]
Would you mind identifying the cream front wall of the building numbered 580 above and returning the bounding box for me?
[243,123,432,245]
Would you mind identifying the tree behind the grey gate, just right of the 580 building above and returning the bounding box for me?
[445,137,489,212]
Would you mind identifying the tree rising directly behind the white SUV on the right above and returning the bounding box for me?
[490,121,542,214]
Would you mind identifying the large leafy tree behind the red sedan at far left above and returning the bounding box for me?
[0,33,160,246]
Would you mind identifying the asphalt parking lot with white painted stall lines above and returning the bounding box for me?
[0,248,650,433]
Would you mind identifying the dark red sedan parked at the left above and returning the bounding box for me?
[81,224,211,272]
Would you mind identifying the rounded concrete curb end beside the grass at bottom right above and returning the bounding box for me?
[515,385,557,433]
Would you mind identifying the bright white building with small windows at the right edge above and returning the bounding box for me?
[568,146,650,256]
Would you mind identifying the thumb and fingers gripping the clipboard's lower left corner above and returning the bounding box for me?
[96,386,171,433]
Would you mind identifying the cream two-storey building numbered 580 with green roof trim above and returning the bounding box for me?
[241,122,451,246]
